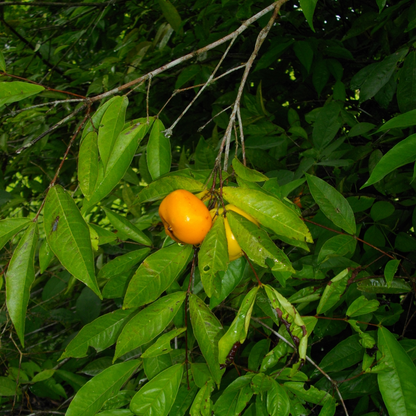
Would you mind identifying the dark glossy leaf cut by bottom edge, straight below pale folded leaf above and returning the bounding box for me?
[213,375,253,416]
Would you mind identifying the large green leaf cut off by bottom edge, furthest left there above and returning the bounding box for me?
[65,360,140,416]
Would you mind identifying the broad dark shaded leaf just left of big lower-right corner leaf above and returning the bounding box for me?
[319,334,364,373]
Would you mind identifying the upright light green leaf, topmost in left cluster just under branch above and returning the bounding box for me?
[97,96,129,169]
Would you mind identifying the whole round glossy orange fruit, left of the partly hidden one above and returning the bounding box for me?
[159,189,212,244]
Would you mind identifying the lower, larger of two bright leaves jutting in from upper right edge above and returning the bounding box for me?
[360,133,416,189]
